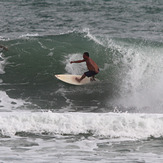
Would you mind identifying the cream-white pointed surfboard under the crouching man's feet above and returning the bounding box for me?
[55,74,99,85]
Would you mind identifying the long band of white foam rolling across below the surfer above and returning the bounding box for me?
[0,112,163,140]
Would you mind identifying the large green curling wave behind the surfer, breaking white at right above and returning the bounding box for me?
[0,30,163,112]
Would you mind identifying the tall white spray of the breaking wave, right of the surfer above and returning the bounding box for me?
[109,41,163,111]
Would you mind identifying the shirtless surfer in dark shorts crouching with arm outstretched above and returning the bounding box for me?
[70,52,99,82]
